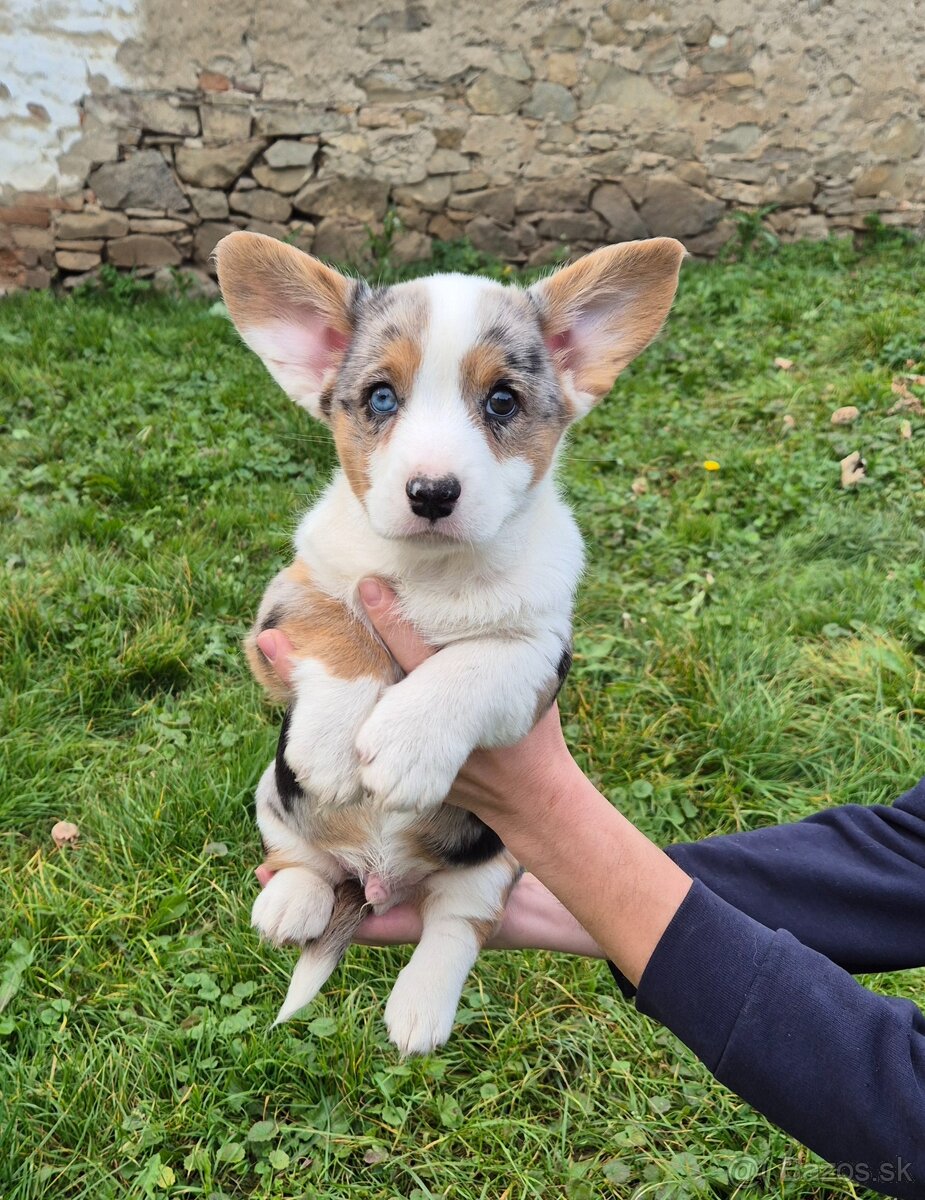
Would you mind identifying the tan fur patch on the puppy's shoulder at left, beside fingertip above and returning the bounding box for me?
[245,558,398,700]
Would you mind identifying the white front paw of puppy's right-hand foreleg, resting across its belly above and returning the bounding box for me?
[356,694,470,810]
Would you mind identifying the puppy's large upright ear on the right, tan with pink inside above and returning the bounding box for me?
[530,238,686,416]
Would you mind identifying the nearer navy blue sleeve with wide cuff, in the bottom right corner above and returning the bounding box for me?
[636,881,925,1200]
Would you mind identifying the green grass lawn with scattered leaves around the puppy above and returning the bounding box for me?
[0,226,925,1200]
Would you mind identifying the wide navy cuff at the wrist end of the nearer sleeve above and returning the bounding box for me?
[633,880,774,1070]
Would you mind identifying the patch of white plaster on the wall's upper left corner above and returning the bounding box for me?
[0,0,139,192]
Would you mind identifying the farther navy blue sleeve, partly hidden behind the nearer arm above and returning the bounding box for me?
[667,780,925,973]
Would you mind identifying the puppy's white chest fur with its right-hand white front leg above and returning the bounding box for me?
[295,474,582,809]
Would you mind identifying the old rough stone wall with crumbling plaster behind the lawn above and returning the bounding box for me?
[0,0,925,287]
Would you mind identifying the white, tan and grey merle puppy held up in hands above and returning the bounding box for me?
[216,233,684,1055]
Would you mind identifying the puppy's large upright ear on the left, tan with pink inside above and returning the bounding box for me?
[215,233,362,420]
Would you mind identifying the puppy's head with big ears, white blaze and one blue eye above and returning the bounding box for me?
[216,233,684,545]
